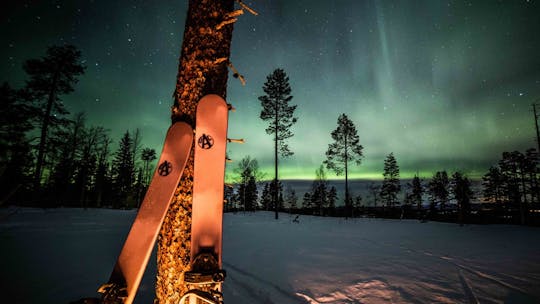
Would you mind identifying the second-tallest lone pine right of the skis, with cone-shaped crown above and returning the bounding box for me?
[324,114,363,216]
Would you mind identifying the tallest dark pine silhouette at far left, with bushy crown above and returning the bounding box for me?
[24,45,85,189]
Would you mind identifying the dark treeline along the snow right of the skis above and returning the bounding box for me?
[225,149,540,225]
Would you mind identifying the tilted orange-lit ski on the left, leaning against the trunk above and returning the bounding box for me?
[99,122,193,304]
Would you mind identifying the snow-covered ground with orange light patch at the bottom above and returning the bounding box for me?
[0,208,540,304]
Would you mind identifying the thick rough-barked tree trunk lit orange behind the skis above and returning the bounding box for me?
[156,0,234,304]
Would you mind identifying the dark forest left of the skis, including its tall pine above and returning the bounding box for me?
[0,45,156,208]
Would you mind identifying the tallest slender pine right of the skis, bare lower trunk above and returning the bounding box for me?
[259,69,297,219]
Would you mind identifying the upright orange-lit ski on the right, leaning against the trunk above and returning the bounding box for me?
[180,95,229,304]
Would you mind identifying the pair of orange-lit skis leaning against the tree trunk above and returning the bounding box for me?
[99,95,229,304]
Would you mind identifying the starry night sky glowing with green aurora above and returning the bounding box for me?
[0,0,540,179]
